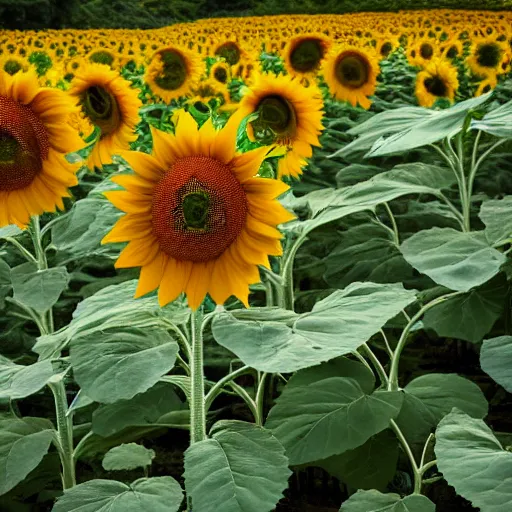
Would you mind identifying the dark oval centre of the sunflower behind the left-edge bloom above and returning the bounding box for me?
[81,85,120,137]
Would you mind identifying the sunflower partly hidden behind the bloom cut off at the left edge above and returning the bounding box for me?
[69,64,142,169]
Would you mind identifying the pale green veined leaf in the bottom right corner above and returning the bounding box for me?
[435,410,512,512]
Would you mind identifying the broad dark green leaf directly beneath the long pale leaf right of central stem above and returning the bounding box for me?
[265,365,403,465]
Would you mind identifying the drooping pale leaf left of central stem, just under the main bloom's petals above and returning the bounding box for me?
[33,280,190,359]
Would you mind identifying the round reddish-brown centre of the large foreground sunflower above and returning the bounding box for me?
[152,156,248,262]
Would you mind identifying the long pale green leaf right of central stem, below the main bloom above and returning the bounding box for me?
[212,283,415,373]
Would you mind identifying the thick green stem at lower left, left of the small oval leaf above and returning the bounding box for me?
[48,374,76,490]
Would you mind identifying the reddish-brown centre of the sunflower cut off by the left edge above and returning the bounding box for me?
[0,96,50,191]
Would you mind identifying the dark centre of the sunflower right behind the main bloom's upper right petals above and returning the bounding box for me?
[251,96,297,143]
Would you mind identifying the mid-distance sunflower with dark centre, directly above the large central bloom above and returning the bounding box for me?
[144,46,203,103]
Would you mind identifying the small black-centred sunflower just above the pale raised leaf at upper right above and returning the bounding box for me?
[416,59,459,107]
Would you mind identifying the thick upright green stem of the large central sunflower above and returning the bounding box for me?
[190,307,206,444]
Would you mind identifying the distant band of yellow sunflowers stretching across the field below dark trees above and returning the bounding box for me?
[0,10,512,108]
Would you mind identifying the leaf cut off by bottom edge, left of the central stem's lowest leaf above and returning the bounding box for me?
[52,476,183,512]
